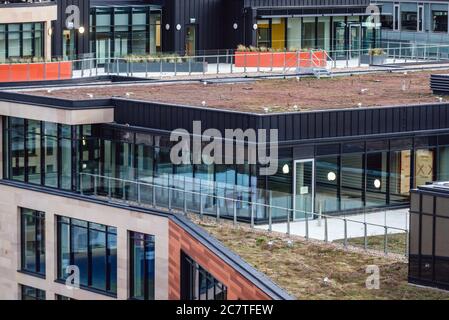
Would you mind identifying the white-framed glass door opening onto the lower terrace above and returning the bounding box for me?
[293,159,315,220]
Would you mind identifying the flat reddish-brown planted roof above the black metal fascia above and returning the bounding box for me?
[18,71,449,113]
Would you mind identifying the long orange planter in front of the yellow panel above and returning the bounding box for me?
[235,46,327,68]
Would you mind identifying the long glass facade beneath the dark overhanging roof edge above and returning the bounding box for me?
[3,117,449,222]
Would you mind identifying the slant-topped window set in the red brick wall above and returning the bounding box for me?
[181,252,227,300]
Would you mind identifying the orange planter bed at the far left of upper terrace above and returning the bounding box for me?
[0,59,72,82]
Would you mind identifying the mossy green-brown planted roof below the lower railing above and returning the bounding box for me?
[195,220,449,300]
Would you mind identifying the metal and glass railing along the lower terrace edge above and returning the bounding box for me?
[79,173,408,255]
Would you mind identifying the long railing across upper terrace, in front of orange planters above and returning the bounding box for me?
[0,42,449,82]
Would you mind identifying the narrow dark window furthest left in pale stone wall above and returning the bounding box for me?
[21,208,45,275]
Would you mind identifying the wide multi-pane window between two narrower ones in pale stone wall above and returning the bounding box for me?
[58,217,117,293]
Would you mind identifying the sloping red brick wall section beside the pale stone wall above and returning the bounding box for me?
[168,221,270,300]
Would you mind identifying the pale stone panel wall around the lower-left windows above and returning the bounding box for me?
[0,186,168,300]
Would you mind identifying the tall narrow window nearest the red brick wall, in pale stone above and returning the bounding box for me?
[130,232,155,300]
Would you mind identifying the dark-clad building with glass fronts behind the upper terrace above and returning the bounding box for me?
[0,0,380,62]
